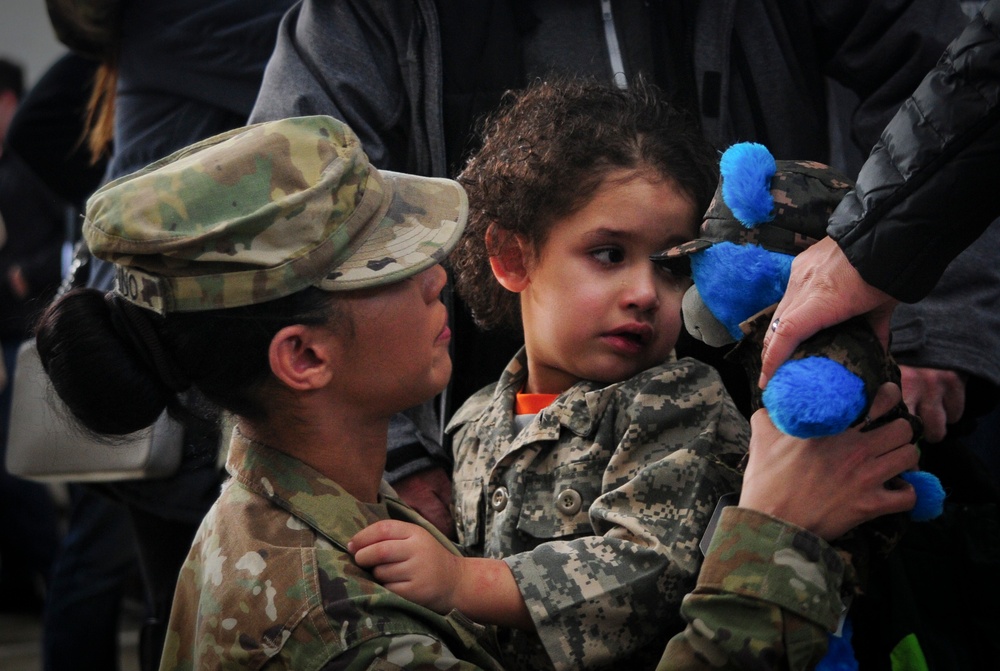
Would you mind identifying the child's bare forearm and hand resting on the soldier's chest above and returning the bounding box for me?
[347,520,534,630]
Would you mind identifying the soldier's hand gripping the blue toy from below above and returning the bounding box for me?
[740,383,918,540]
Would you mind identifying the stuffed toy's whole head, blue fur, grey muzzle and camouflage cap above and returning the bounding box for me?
[652,142,853,347]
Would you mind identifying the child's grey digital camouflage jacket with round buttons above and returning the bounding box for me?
[448,350,749,669]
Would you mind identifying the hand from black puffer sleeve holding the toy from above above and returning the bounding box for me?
[758,238,896,388]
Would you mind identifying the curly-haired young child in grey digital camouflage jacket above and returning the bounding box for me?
[350,82,749,668]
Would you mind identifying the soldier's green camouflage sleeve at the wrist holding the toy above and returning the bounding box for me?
[656,507,846,671]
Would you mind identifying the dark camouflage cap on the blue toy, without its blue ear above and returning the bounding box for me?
[652,161,854,275]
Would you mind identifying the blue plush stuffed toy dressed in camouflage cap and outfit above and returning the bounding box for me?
[652,143,944,669]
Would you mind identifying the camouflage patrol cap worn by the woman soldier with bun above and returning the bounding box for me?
[83,116,468,314]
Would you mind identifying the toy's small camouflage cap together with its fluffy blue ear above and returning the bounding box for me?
[651,142,854,270]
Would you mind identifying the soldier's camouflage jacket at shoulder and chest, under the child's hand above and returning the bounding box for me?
[160,431,500,671]
